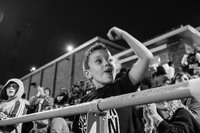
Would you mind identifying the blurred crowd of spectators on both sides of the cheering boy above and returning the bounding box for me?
[1,62,200,133]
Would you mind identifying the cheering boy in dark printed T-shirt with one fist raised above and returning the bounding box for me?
[72,27,153,133]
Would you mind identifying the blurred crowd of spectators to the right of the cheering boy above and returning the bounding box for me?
[140,57,200,133]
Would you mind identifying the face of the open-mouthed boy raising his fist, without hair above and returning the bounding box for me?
[87,50,116,87]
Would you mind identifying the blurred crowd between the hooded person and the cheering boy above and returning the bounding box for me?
[18,80,95,133]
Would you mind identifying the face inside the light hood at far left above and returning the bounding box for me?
[6,83,19,97]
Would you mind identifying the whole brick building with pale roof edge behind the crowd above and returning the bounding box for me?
[21,25,200,99]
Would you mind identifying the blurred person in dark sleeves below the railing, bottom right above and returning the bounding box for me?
[145,100,200,133]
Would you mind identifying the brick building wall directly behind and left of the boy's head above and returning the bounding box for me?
[22,38,124,99]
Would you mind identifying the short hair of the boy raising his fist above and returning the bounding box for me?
[83,42,108,72]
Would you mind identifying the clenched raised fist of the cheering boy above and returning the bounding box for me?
[107,27,122,40]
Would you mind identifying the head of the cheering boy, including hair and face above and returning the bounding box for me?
[83,43,116,88]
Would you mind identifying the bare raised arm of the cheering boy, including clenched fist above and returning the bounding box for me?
[107,27,153,85]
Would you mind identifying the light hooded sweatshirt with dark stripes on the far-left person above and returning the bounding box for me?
[0,78,26,133]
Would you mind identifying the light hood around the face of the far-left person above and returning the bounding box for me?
[0,78,24,100]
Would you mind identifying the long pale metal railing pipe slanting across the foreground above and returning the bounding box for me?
[0,78,200,132]
